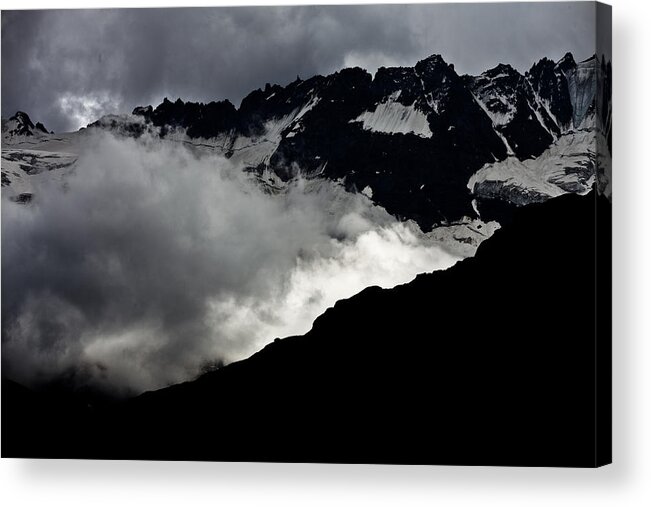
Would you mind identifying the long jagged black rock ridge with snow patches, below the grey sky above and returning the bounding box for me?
[126,53,610,230]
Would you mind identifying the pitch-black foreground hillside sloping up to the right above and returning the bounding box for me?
[2,194,610,466]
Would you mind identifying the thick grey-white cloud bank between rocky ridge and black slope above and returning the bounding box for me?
[2,132,457,395]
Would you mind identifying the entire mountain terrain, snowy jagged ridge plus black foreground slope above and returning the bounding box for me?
[2,53,612,466]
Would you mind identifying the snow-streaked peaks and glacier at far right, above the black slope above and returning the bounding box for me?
[466,53,611,213]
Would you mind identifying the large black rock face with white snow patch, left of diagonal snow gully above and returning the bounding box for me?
[134,55,506,230]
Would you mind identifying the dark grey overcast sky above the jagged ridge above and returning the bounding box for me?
[2,2,595,131]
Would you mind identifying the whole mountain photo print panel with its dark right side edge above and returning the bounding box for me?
[2,2,612,467]
